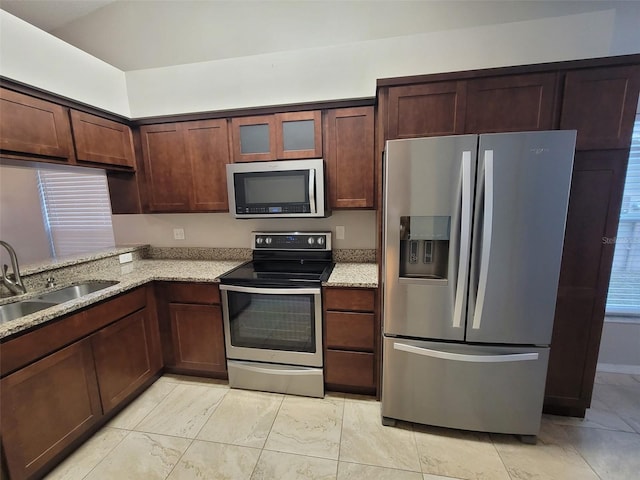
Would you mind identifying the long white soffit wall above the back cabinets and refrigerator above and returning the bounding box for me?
[126,9,640,117]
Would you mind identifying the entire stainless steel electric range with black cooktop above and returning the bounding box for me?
[220,232,333,397]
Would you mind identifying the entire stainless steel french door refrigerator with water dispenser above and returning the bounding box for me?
[382,131,576,439]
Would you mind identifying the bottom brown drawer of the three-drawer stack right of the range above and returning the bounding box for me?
[324,350,375,388]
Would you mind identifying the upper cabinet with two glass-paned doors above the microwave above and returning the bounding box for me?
[231,111,322,163]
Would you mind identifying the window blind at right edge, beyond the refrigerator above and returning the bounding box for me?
[607,115,640,316]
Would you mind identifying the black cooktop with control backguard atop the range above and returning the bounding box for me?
[220,232,334,287]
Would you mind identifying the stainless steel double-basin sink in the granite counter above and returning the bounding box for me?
[0,280,118,323]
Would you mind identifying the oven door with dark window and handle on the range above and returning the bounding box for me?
[220,285,322,367]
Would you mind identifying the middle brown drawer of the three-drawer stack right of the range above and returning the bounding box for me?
[325,312,374,352]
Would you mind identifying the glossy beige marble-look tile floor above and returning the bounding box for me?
[46,373,640,480]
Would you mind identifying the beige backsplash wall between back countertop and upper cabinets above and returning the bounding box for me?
[113,210,376,249]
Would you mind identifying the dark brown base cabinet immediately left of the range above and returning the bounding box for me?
[158,283,227,378]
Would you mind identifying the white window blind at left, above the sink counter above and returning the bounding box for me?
[38,169,115,257]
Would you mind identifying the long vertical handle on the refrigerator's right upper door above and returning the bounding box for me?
[471,150,494,330]
